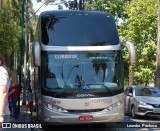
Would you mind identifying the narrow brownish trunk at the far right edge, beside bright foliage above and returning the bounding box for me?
[155,0,160,88]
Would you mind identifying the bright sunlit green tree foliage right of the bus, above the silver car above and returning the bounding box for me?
[119,0,158,85]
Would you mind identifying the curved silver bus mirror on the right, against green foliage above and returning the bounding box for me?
[124,42,136,65]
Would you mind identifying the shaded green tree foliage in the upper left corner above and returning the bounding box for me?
[0,0,33,69]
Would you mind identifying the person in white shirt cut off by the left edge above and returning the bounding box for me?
[0,53,10,127]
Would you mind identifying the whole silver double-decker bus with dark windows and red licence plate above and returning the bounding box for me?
[33,10,135,125]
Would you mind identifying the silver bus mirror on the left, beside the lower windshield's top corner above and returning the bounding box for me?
[33,42,41,67]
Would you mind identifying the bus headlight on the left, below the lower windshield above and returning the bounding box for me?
[45,103,68,113]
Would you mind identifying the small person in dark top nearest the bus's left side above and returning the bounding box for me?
[26,87,33,114]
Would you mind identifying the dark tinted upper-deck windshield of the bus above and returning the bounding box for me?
[41,11,119,46]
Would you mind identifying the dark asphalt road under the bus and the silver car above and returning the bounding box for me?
[39,116,160,131]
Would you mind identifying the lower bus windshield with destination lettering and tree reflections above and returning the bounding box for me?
[42,52,123,95]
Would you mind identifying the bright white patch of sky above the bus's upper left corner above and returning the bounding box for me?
[32,0,64,15]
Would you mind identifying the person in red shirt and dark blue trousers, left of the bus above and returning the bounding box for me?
[8,77,19,120]
